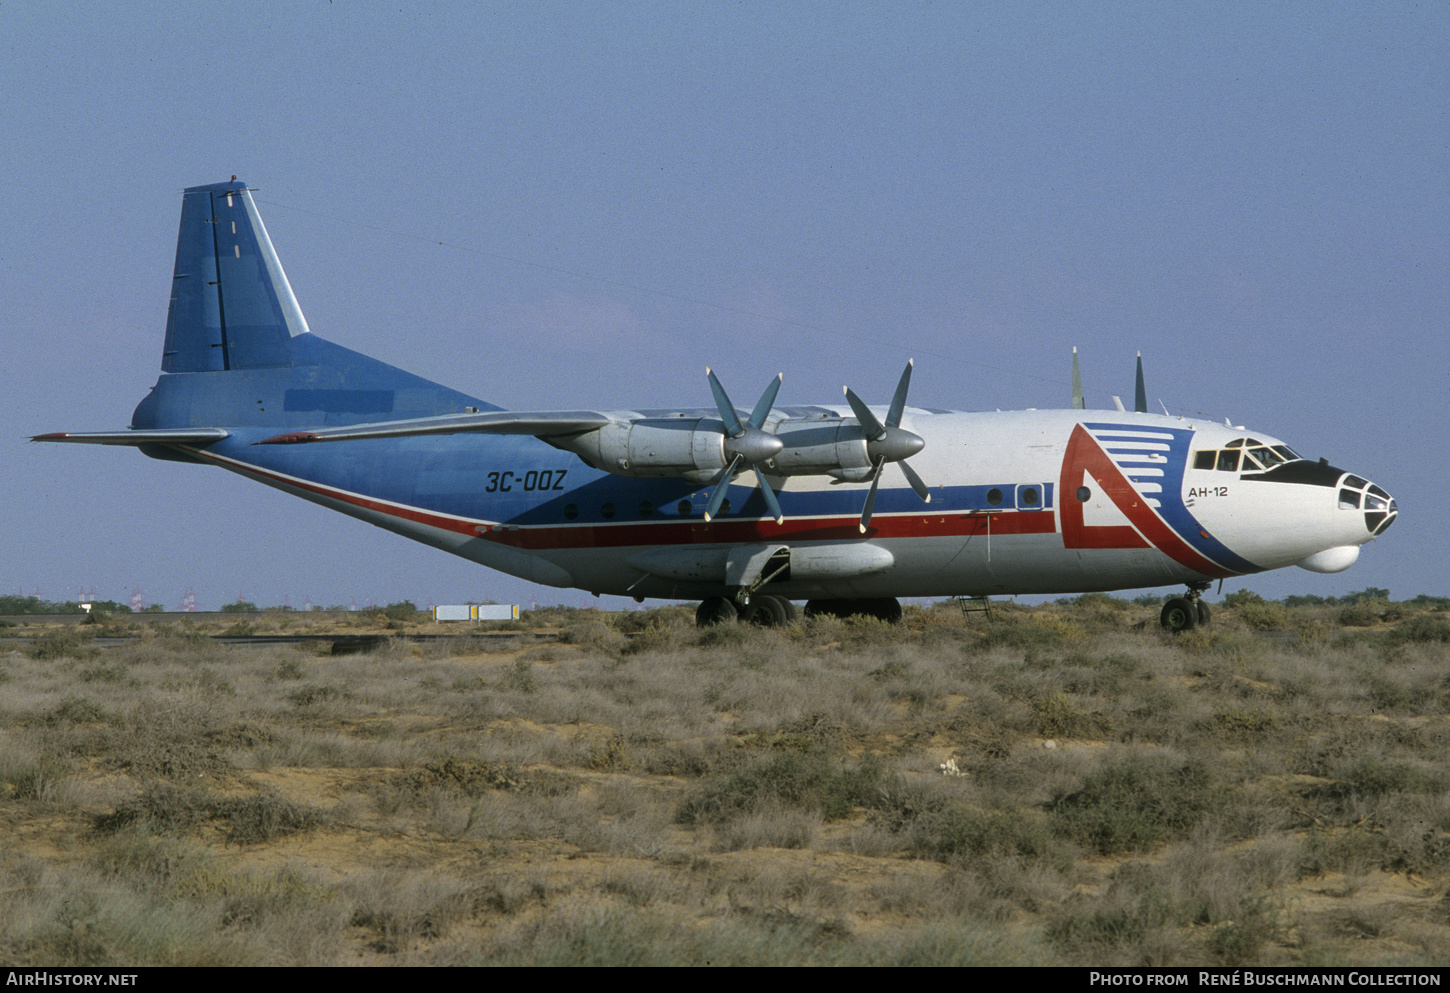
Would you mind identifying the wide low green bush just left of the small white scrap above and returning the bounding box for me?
[674,751,885,825]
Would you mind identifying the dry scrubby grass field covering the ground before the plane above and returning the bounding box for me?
[0,596,1450,965]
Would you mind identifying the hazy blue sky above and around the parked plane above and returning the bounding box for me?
[0,0,1450,607]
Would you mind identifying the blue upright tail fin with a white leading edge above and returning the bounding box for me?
[161,178,307,373]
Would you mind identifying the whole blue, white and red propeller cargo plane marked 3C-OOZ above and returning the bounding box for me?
[36,177,1398,631]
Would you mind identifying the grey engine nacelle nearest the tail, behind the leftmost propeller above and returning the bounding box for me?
[550,417,726,484]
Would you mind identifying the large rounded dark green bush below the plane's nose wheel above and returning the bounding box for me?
[1048,758,1235,855]
